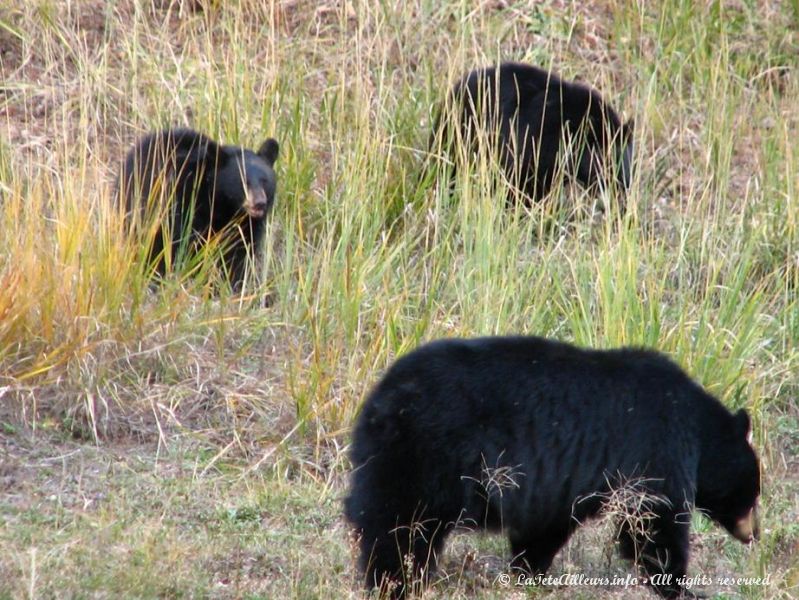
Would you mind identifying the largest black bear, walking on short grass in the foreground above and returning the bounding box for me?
[345,337,760,598]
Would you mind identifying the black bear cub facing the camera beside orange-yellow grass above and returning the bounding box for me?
[117,129,279,286]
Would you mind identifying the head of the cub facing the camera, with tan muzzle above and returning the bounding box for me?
[214,138,280,220]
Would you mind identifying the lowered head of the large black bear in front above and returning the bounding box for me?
[695,409,760,543]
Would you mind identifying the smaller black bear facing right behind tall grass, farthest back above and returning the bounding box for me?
[432,63,632,204]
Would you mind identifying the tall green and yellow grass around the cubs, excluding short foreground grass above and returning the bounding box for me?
[0,0,799,597]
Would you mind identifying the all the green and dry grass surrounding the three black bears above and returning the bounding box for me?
[0,0,799,598]
